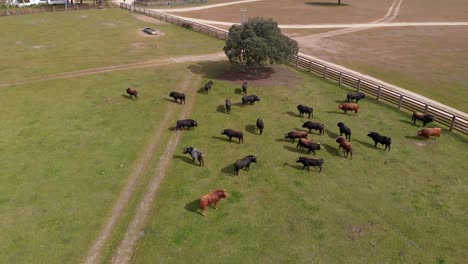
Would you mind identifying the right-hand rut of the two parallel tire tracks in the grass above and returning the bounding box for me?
[112,71,198,264]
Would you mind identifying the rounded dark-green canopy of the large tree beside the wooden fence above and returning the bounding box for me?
[223,18,298,65]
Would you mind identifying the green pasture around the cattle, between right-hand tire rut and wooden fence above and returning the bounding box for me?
[132,62,468,263]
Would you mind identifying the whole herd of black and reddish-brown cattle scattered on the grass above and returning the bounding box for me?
[126,80,442,216]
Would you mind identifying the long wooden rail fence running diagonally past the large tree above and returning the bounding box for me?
[120,3,468,134]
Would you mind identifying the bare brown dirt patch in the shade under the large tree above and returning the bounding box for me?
[218,66,299,86]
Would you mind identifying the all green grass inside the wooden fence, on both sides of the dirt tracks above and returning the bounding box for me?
[0,9,468,263]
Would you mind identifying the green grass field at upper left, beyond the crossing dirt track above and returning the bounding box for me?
[0,8,223,83]
